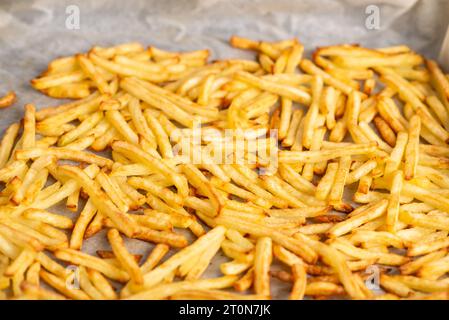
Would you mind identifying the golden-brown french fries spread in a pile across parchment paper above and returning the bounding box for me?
[0,36,449,300]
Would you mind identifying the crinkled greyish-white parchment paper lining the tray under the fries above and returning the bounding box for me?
[0,0,449,298]
